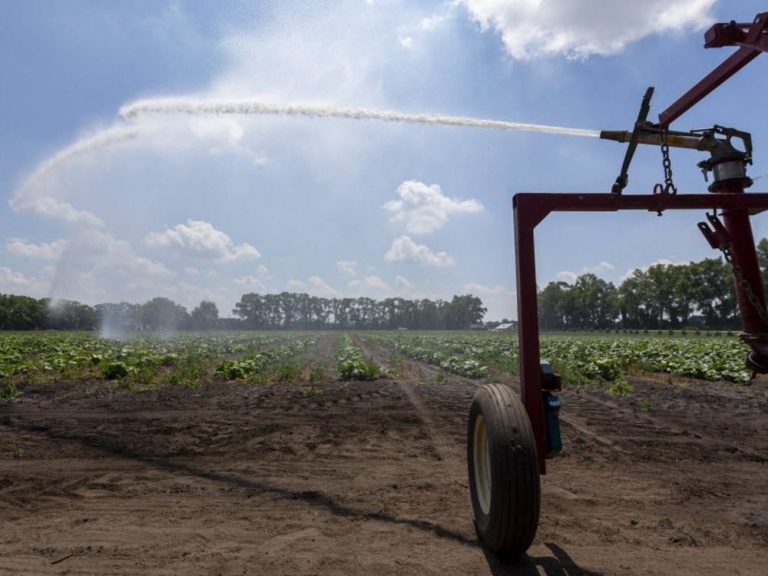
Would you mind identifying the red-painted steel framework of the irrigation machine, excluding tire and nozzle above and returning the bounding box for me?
[513,12,768,474]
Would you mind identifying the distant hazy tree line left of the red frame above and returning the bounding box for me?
[0,292,486,332]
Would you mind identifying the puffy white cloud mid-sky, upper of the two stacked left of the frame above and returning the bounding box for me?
[384,180,483,234]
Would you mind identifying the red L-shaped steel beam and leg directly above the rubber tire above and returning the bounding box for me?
[512,189,768,474]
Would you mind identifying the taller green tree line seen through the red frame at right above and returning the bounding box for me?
[538,238,768,330]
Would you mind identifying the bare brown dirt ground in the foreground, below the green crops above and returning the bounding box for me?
[0,340,768,576]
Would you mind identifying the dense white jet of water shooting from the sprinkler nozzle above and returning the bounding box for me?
[119,99,600,138]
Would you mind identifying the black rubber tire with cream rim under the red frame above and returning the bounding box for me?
[467,384,541,559]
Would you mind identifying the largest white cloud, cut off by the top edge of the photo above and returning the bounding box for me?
[457,0,716,59]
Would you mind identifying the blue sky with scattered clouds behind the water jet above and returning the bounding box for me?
[0,0,768,319]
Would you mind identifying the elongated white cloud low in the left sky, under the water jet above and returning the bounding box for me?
[144,220,261,262]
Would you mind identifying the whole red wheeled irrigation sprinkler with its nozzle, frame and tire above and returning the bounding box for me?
[467,12,768,557]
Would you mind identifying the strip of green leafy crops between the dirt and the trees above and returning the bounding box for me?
[0,332,751,397]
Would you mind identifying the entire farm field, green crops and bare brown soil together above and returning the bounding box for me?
[0,331,768,575]
